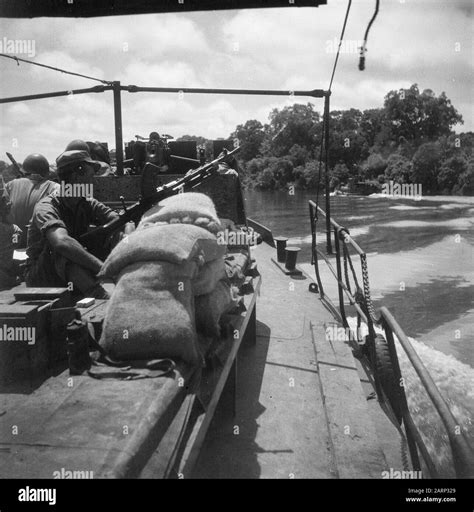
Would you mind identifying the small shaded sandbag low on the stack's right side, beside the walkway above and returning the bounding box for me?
[194,280,238,338]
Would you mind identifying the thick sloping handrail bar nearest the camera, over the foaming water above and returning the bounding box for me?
[379,307,474,478]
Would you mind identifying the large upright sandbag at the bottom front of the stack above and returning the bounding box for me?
[100,262,201,365]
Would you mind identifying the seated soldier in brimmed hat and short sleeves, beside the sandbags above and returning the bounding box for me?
[26,150,118,299]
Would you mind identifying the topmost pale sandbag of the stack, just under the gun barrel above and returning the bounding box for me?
[139,192,221,234]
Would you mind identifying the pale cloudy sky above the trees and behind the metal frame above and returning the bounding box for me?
[0,0,474,162]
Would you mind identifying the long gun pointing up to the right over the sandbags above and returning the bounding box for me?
[79,147,240,253]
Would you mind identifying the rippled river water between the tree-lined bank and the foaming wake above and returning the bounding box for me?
[245,191,474,367]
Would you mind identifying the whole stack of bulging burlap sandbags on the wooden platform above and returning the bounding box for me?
[100,193,241,364]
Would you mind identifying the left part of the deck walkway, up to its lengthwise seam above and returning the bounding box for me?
[194,245,335,478]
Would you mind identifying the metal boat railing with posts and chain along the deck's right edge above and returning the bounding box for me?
[309,201,474,478]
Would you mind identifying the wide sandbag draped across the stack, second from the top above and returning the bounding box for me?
[98,224,226,279]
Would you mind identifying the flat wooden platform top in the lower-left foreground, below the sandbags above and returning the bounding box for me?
[0,362,193,478]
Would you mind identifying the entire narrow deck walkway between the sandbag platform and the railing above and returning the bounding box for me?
[195,245,386,478]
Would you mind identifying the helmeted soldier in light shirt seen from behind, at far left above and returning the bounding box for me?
[5,153,59,247]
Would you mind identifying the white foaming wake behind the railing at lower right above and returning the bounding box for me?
[348,318,474,478]
